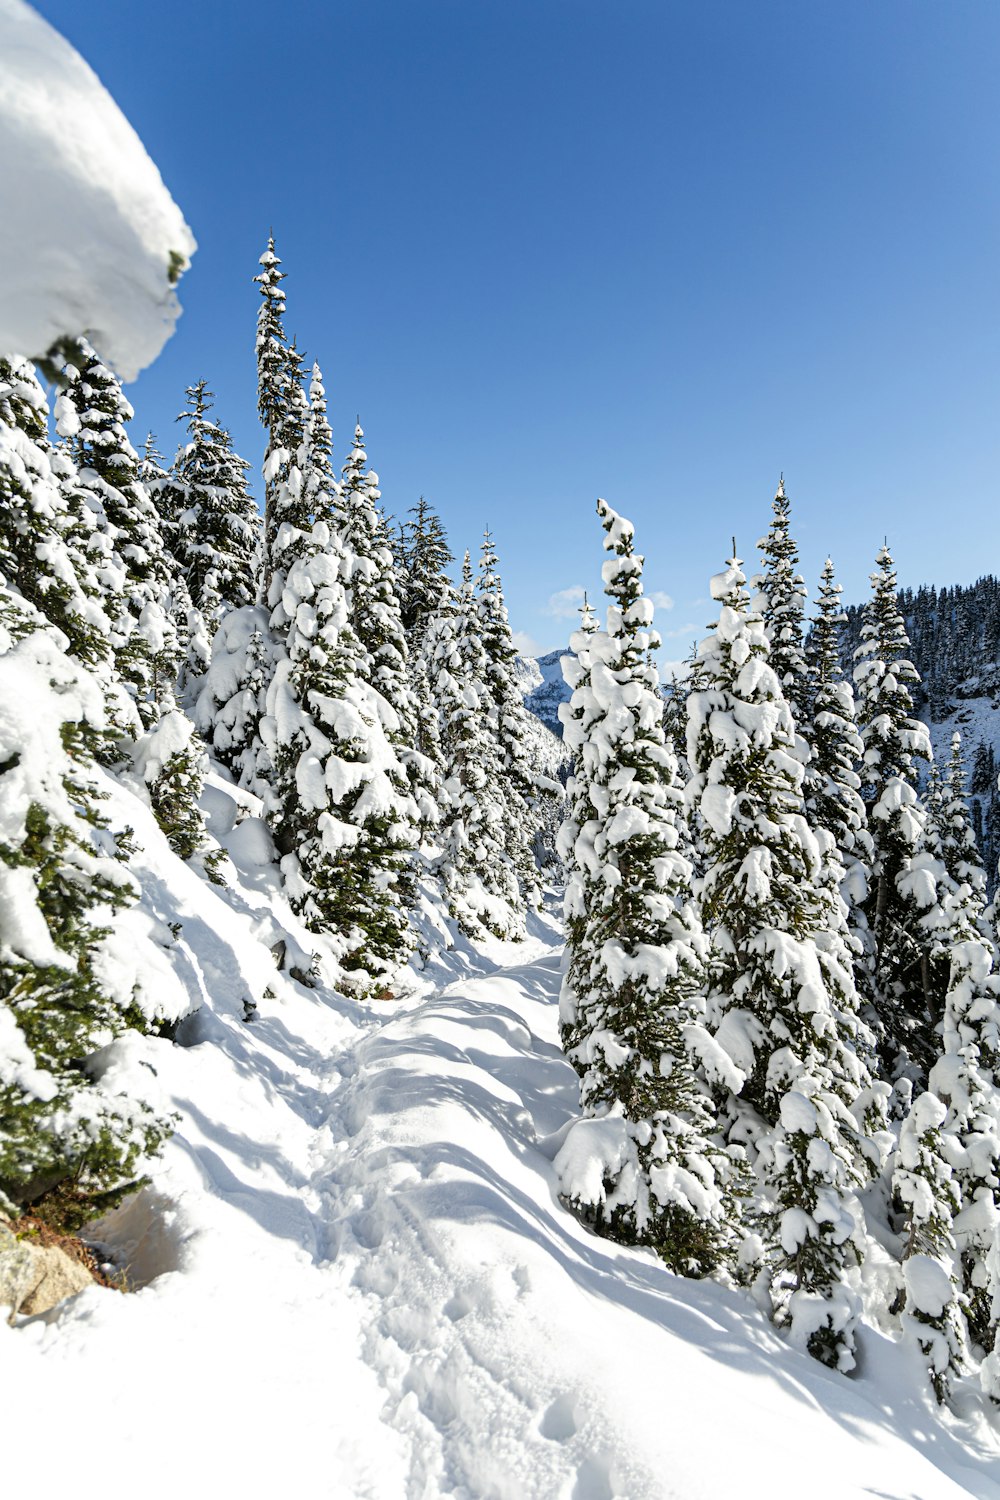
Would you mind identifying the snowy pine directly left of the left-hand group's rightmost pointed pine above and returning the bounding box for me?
[421,564,525,939]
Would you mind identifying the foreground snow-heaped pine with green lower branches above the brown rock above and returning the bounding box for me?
[0,591,186,1227]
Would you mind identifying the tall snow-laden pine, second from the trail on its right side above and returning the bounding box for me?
[687,558,871,1370]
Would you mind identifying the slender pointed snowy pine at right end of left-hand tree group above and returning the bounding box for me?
[477,531,562,908]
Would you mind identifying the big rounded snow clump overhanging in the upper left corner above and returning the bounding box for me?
[0,0,195,380]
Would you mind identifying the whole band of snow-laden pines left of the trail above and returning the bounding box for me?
[0,240,562,1223]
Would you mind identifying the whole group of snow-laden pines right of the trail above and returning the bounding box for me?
[556,486,1000,1401]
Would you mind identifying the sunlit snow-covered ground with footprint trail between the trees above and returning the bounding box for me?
[0,783,1000,1500]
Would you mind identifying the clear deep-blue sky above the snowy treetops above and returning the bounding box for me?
[36,0,1000,657]
